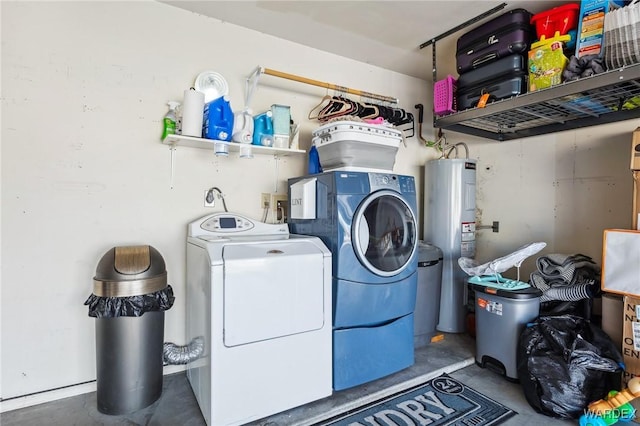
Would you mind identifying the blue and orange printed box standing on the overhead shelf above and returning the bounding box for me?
[576,0,624,58]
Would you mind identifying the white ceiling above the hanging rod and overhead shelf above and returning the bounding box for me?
[160,0,567,80]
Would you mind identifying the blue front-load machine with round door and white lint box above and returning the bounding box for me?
[288,171,418,390]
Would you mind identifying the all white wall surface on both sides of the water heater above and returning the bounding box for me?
[0,1,640,406]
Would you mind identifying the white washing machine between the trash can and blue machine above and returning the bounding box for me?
[187,212,332,426]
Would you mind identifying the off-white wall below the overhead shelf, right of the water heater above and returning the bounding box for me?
[455,124,640,281]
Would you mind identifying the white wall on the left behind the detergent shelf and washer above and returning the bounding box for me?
[0,2,428,410]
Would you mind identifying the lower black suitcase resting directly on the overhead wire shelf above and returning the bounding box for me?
[457,53,529,111]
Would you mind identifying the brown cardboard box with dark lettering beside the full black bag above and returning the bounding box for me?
[621,296,640,423]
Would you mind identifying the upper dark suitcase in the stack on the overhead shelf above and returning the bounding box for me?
[456,9,535,74]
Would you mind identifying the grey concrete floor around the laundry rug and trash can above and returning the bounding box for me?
[0,334,577,426]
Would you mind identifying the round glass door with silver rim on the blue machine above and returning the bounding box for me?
[352,190,418,277]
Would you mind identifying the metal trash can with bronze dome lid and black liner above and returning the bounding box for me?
[84,246,175,415]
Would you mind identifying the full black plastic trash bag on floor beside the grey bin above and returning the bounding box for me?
[517,314,624,419]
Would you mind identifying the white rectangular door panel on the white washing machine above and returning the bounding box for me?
[223,240,331,347]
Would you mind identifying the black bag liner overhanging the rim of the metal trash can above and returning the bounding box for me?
[84,285,176,318]
